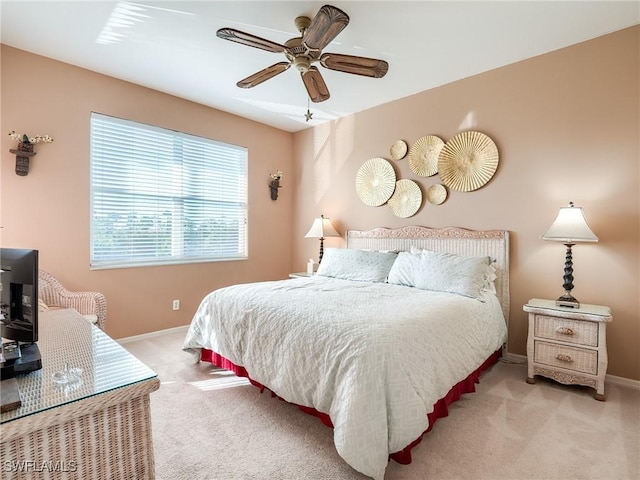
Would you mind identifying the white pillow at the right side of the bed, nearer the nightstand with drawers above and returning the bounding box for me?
[389,250,491,298]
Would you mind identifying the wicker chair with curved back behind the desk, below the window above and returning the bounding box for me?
[38,270,107,330]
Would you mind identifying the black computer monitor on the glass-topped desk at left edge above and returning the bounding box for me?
[0,248,42,379]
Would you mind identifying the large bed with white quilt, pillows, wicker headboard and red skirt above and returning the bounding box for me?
[183,226,509,480]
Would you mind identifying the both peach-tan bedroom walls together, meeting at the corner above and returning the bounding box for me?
[0,27,640,380]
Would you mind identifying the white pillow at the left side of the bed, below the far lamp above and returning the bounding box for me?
[316,248,398,282]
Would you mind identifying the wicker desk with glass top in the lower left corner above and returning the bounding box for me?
[0,309,160,480]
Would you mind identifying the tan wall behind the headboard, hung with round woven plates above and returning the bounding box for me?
[293,27,640,380]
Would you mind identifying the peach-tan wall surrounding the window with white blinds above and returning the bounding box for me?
[0,45,293,338]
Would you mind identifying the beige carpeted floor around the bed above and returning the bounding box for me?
[124,330,640,480]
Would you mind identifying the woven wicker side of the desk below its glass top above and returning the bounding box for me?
[0,378,159,480]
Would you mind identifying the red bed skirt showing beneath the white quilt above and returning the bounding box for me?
[200,348,502,465]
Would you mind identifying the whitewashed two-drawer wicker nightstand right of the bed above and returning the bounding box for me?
[523,298,613,401]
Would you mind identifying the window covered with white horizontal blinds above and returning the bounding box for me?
[91,113,247,269]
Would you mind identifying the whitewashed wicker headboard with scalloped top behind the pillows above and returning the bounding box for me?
[347,226,510,326]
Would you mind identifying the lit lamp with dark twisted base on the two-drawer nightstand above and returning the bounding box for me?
[542,202,598,308]
